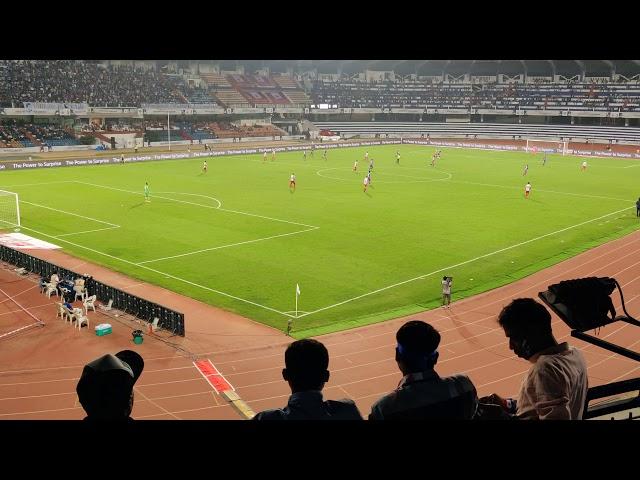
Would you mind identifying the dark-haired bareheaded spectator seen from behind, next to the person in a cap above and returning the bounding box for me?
[253,339,362,420]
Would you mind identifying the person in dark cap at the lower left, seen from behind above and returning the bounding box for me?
[76,350,144,421]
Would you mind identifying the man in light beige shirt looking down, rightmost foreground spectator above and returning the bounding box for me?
[481,298,588,420]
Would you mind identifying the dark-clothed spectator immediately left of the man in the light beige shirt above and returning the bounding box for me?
[369,320,478,420]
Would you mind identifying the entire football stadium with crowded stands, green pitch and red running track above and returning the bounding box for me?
[0,60,640,420]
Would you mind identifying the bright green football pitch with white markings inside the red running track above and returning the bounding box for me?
[0,145,640,337]
